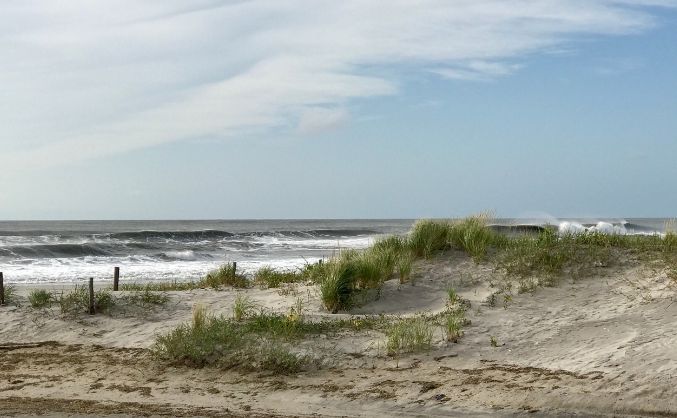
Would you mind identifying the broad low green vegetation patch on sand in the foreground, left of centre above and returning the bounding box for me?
[152,300,402,374]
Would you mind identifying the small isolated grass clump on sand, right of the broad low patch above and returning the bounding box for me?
[386,317,433,355]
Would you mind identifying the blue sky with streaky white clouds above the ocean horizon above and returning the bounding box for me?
[0,0,677,220]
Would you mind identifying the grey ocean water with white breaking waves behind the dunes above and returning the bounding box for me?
[0,218,667,283]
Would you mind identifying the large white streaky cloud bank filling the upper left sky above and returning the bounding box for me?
[0,0,675,167]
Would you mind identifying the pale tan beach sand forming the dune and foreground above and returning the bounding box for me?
[0,253,677,417]
